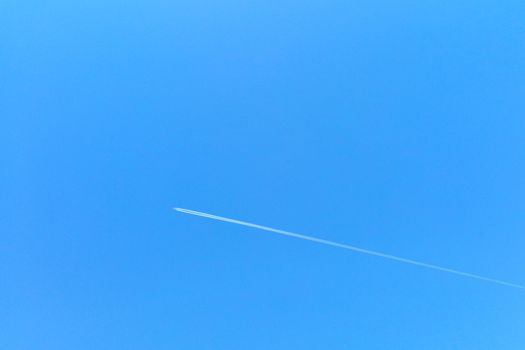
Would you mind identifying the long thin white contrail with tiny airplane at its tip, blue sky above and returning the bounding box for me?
[173,208,525,290]
